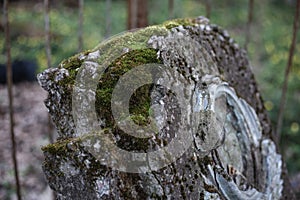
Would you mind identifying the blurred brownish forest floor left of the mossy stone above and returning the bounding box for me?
[0,83,52,200]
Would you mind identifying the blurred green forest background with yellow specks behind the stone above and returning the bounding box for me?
[0,0,300,199]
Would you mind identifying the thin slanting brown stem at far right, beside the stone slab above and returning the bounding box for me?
[276,0,300,143]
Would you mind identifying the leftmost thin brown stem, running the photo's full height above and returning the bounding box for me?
[3,0,22,200]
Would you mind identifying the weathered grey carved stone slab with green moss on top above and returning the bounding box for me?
[38,17,290,200]
